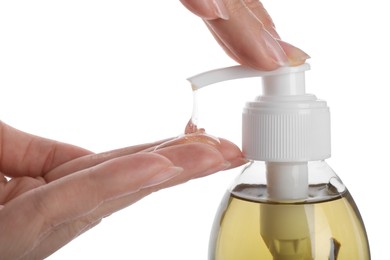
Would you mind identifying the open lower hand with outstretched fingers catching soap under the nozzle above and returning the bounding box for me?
[0,122,245,259]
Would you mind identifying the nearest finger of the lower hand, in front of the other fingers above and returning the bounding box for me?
[0,153,182,259]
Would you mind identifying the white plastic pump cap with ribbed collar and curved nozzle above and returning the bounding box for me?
[188,64,330,162]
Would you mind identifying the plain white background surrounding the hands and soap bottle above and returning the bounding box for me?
[0,0,390,259]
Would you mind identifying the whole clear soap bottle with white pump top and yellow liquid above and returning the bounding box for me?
[189,64,370,260]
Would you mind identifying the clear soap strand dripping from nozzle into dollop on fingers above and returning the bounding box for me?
[155,90,221,150]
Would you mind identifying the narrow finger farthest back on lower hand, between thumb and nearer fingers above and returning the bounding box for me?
[44,139,170,182]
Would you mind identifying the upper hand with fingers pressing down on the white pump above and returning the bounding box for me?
[180,0,309,70]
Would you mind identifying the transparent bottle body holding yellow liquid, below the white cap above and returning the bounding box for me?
[209,161,370,260]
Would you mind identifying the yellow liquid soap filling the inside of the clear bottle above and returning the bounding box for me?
[209,185,370,260]
